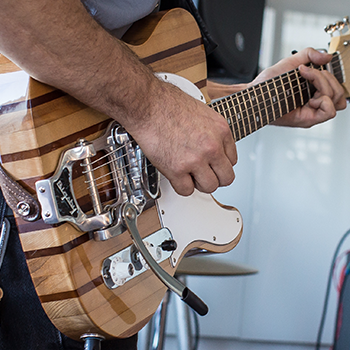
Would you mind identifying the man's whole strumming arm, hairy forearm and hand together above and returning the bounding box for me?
[0,0,237,195]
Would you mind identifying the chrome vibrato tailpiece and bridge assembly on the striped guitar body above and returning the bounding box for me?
[36,122,159,240]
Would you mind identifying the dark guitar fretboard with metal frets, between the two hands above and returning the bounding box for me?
[209,52,344,141]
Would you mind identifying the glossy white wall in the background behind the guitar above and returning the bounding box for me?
[165,0,350,343]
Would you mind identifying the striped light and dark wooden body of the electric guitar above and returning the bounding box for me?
[0,9,242,339]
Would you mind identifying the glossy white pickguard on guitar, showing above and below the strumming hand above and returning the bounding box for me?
[157,73,243,266]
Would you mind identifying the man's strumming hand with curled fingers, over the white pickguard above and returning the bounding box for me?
[123,77,237,196]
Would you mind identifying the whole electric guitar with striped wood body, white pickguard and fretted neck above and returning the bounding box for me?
[0,9,350,339]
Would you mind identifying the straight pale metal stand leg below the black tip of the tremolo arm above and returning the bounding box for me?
[175,276,192,350]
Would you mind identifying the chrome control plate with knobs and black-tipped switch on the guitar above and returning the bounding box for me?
[101,228,172,289]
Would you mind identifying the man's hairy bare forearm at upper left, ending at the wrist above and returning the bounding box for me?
[0,0,157,131]
